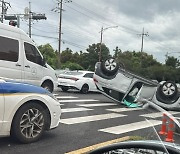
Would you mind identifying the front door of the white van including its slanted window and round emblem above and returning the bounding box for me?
[23,42,45,86]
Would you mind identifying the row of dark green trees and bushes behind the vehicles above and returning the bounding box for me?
[38,43,180,83]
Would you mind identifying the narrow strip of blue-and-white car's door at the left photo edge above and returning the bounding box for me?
[0,81,4,131]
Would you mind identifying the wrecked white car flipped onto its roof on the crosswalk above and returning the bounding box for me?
[94,58,180,110]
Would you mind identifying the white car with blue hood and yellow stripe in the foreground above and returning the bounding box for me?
[0,79,61,143]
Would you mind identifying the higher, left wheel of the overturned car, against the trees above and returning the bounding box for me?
[101,58,119,75]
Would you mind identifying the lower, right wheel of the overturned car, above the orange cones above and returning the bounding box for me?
[158,81,178,98]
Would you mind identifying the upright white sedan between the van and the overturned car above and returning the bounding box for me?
[58,71,97,94]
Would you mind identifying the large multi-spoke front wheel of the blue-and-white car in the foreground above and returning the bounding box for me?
[11,102,48,143]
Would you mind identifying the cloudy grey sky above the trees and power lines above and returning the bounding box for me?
[5,0,180,62]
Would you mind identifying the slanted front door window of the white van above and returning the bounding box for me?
[24,42,42,65]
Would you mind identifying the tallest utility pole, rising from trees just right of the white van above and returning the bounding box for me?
[51,0,72,66]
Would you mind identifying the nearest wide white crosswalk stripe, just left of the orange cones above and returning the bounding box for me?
[98,120,162,134]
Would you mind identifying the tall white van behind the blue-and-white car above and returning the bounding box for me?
[0,23,57,92]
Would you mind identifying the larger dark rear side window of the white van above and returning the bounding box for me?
[0,36,19,62]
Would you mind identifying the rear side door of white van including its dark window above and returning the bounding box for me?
[0,34,22,81]
